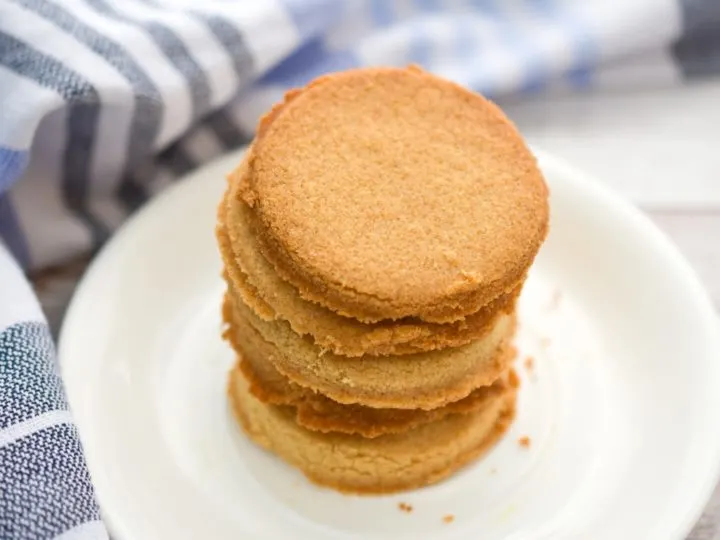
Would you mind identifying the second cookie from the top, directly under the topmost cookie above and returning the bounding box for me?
[217,165,522,356]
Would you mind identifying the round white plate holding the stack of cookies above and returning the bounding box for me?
[60,148,720,540]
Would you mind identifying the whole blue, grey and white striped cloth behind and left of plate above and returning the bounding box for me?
[0,0,720,539]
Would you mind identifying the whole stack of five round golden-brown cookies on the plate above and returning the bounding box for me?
[217,67,548,493]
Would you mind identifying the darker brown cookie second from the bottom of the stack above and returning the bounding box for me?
[236,322,518,438]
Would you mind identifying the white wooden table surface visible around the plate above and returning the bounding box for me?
[34,81,720,540]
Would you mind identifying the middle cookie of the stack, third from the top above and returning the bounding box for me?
[223,293,515,410]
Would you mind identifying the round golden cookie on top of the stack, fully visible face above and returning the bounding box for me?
[242,68,548,322]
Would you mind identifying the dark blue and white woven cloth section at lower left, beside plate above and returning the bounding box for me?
[0,244,107,540]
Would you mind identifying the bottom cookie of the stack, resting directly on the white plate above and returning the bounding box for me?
[229,364,515,494]
